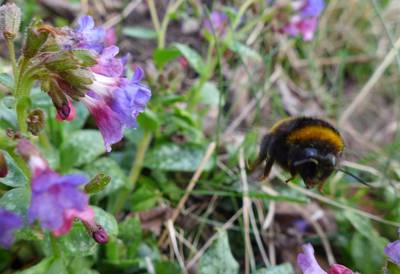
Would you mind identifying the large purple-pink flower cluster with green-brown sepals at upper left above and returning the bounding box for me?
[25,16,151,151]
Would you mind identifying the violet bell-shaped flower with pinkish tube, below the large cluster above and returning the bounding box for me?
[17,139,94,236]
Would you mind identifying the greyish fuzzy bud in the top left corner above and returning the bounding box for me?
[0,4,21,40]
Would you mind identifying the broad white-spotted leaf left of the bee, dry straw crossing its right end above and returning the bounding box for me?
[144,143,213,172]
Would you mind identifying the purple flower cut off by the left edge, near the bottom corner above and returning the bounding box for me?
[0,208,22,248]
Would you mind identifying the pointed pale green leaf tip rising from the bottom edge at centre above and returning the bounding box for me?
[197,230,239,274]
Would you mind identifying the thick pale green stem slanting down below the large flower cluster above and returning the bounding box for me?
[113,130,153,214]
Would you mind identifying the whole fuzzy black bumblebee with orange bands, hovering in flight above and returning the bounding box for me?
[254,117,344,191]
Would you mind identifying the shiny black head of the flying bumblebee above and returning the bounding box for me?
[291,147,338,186]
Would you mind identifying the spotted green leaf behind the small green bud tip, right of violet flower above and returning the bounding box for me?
[84,157,127,196]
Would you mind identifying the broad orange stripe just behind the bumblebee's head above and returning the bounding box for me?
[287,125,344,152]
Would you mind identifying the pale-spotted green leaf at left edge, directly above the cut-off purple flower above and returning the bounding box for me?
[0,187,31,219]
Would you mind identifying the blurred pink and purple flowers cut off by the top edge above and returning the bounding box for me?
[283,0,325,41]
